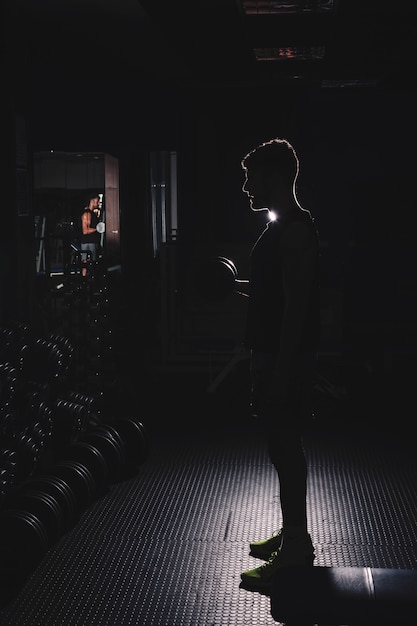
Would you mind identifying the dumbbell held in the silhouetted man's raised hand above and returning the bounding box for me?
[195,256,248,301]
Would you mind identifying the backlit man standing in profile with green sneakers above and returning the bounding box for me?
[241,139,320,590]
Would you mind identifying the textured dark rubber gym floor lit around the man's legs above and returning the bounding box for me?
[0,356,417,626]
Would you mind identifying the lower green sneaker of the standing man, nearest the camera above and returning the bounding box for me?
[240,541,315,592]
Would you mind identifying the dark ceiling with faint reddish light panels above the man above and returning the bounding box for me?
[4,0,417,90]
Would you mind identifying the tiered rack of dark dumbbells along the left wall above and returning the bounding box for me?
[0,258,149,604]
